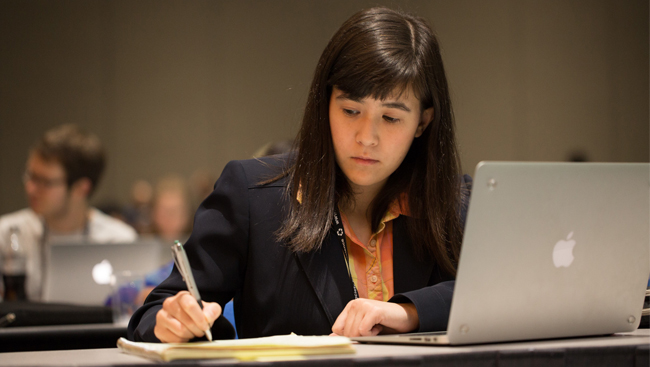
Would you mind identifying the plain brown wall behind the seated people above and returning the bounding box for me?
[0,0,649,214]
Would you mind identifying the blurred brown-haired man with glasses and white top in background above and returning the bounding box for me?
[0,124,137,301]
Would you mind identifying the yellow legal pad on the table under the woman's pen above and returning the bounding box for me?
[117,334,356,361]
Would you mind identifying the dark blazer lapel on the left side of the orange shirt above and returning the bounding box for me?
[296,231,354,325]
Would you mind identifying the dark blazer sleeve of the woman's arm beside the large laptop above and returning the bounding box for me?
[389,175,472,332]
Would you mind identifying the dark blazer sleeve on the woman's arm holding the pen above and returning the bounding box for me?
[127,161,250,342]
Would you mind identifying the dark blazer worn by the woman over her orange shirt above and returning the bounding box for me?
[128,156,467,341]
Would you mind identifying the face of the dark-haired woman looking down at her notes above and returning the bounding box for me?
[329,87,433,196]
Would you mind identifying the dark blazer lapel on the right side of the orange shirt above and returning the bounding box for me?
[393,216,433,294]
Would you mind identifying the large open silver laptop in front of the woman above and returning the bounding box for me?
[353,162,650,345]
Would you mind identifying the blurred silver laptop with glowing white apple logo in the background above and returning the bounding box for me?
[43,240,161,305]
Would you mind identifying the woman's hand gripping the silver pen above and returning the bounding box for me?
[153,291,221,343]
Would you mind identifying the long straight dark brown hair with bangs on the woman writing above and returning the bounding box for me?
[277,8,462,275]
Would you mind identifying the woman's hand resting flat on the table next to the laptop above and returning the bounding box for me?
[332,298,420,337]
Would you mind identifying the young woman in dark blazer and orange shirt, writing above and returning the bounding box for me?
[128,8,469,342]
